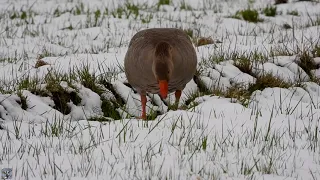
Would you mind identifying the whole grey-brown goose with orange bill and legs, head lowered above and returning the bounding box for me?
[124,28,197,119]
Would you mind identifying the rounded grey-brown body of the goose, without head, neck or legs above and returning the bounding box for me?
[125,28,197,94]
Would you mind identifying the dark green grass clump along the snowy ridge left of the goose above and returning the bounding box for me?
[13,65,124,120]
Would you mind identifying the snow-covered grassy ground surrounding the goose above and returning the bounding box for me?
[0,0,320,180]
